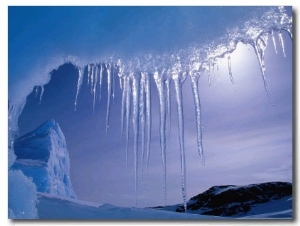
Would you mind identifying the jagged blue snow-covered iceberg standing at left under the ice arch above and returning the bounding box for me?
[11,119,76,198]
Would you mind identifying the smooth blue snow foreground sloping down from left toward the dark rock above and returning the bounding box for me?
[37,193,222,220]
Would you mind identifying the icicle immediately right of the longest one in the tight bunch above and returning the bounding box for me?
[139,72,147,182]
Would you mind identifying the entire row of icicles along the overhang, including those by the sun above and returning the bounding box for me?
[32,27,292,211]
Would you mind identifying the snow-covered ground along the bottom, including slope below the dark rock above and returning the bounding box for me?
[37,193,292,221]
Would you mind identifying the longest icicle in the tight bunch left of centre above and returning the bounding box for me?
[132,74,140,204]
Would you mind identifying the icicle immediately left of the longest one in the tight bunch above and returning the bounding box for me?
[124,76,131,170]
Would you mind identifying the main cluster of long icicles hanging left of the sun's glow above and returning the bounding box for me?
[75,61,205,211]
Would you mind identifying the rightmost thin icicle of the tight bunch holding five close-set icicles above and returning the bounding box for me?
[145,74,151,172]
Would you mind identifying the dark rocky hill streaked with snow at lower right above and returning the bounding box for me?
[161,182,292,216]
